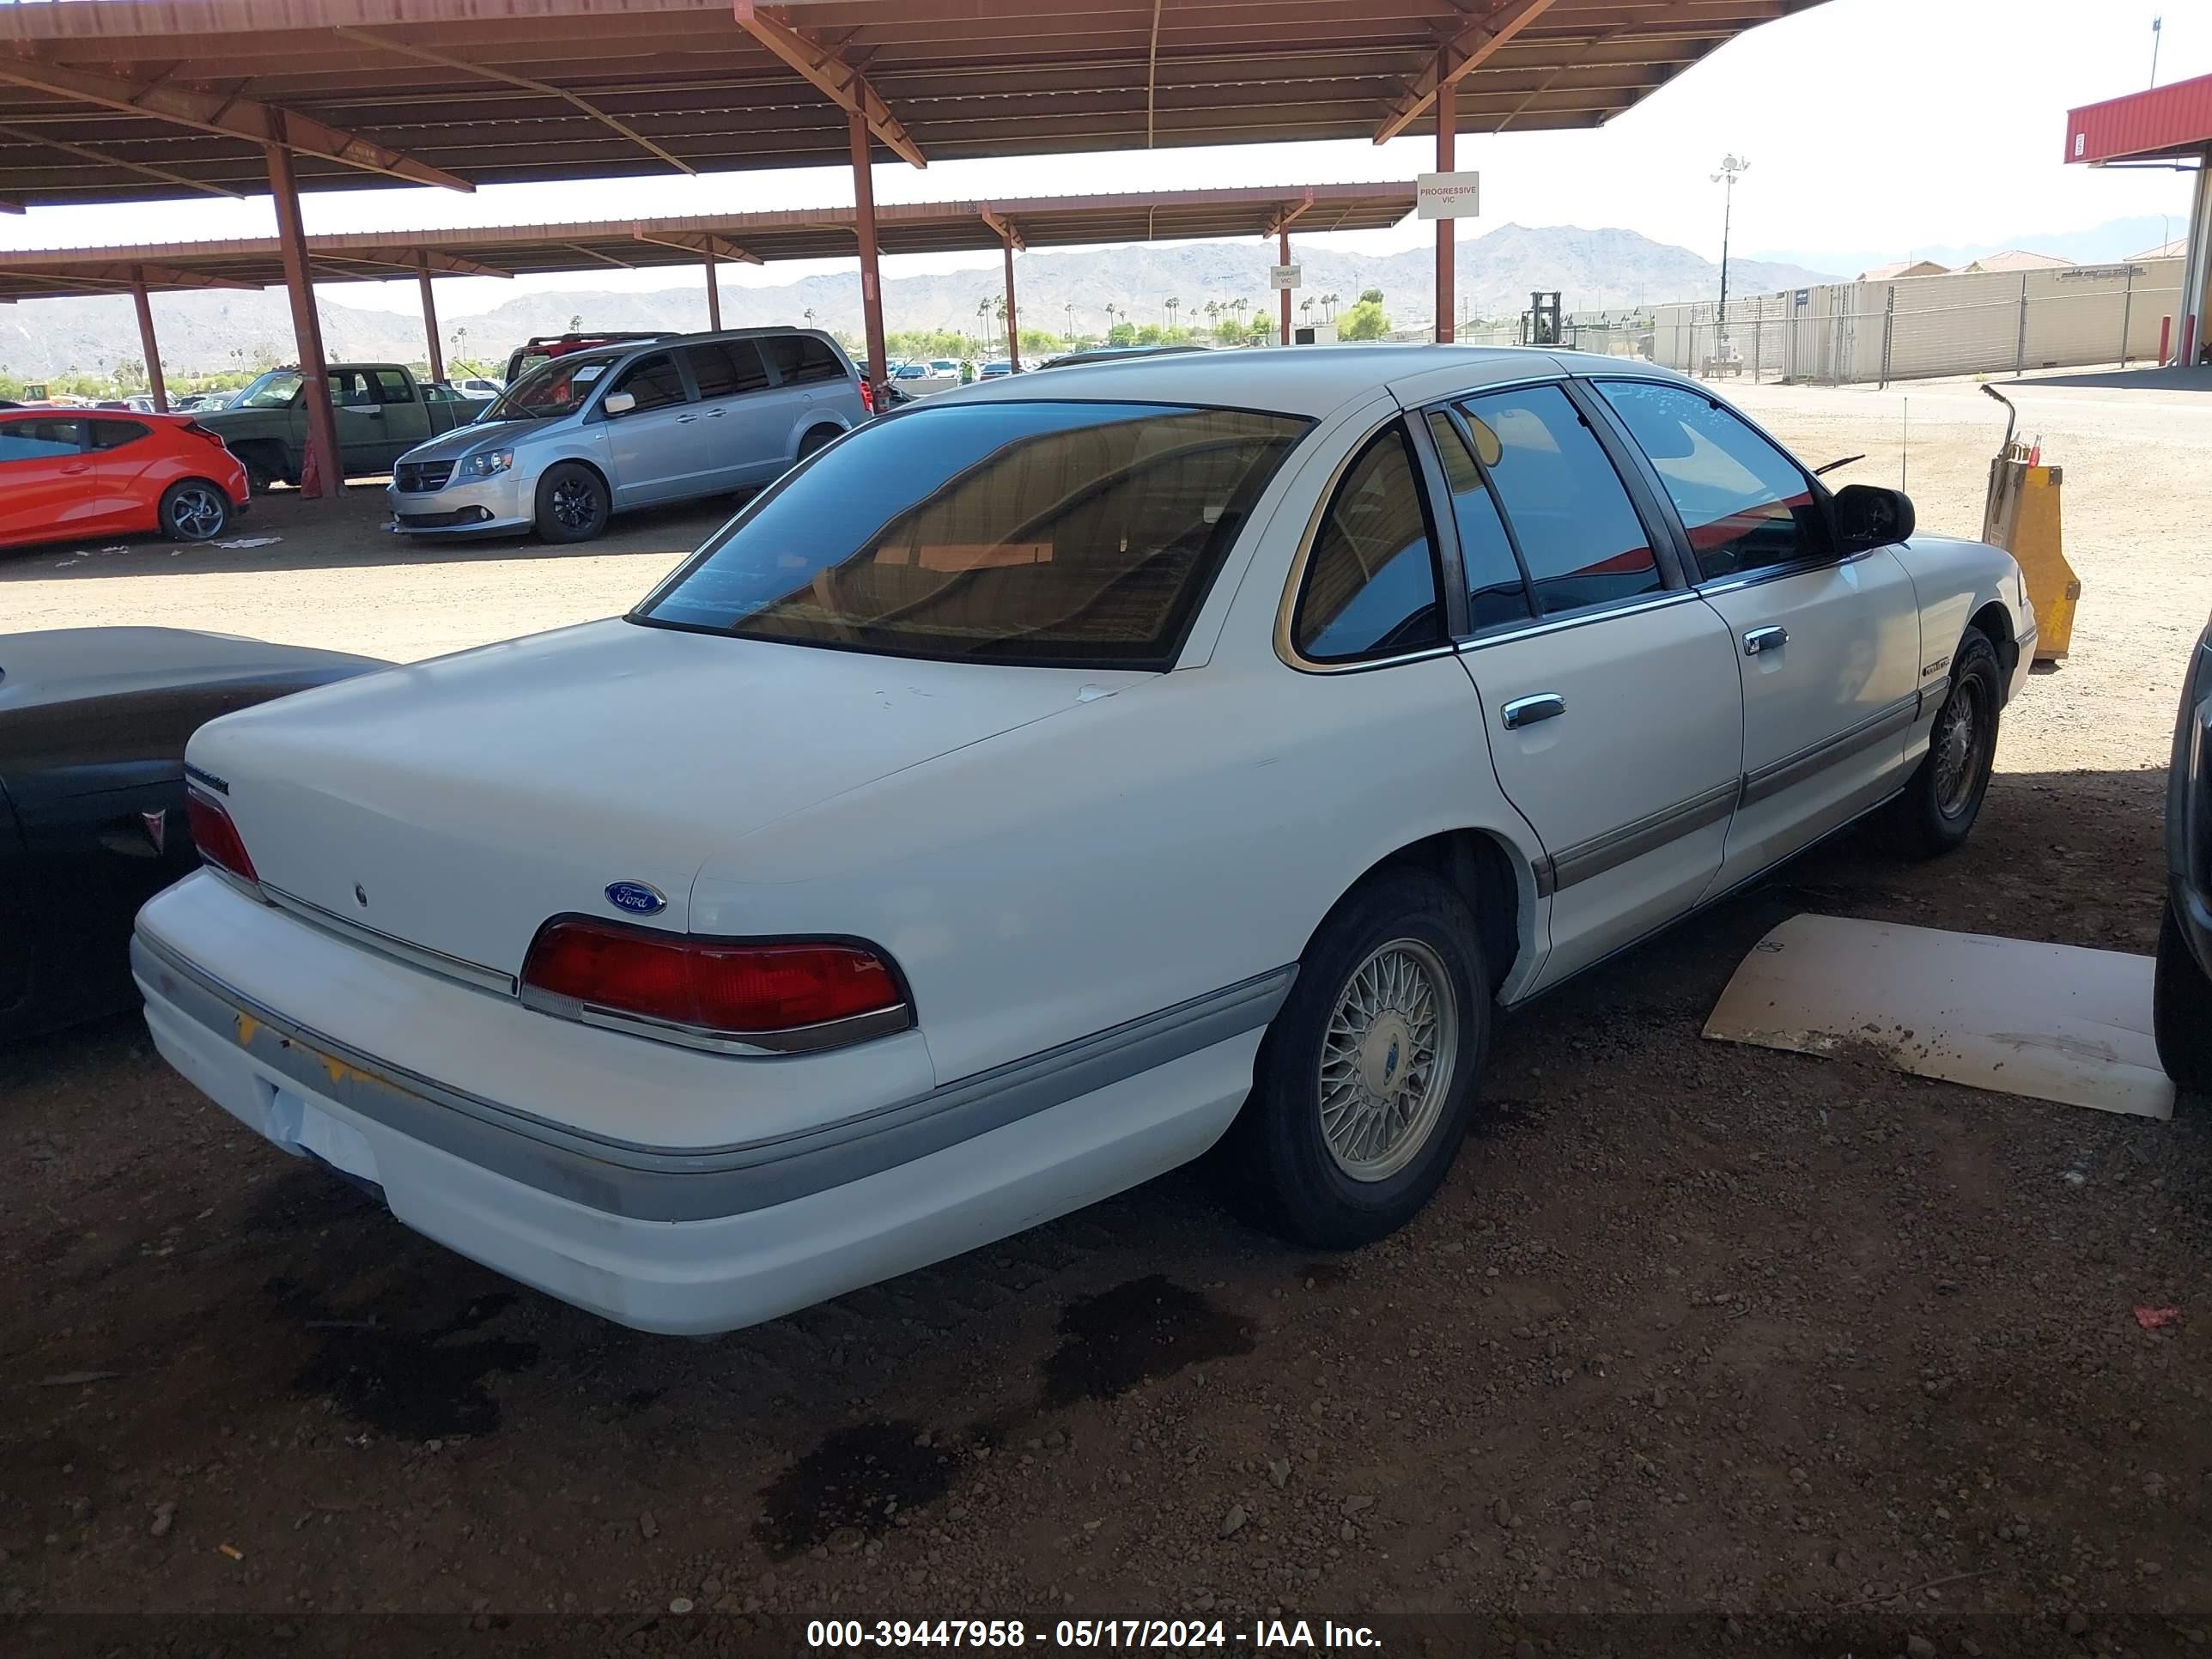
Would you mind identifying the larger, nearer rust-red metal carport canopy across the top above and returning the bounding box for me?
[0,0,1820,206]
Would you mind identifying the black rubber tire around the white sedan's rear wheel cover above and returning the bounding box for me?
[1230,869,1491,1249]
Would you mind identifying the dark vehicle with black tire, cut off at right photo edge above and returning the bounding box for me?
[2152,623,2212,1095]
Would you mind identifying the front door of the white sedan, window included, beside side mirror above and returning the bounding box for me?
[1597,380,1920,891]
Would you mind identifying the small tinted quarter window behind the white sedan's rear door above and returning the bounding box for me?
[1291,422,1444,661]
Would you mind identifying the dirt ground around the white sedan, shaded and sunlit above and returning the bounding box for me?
[0,369,2212,1655]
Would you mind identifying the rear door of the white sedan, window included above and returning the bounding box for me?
[1422,383,1743,988]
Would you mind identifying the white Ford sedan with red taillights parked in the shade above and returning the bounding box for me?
[135,347,2035,1332]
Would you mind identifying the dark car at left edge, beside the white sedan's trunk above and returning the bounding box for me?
[0,629,383,1042]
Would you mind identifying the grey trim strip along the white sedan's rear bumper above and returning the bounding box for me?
[131,933,1298,1221]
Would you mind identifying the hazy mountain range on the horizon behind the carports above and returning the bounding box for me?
[0,223,1832,378]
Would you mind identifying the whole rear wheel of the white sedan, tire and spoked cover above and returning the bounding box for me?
[1241,869,1491,1249]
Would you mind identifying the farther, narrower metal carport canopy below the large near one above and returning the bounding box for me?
[0,184,1413,301]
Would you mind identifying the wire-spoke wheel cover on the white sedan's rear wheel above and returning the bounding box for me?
[1316,938,1460,1182]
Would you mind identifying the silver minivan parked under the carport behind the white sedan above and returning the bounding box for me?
[387,327,872,542]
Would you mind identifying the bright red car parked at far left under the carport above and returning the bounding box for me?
[0,410,248,546]
